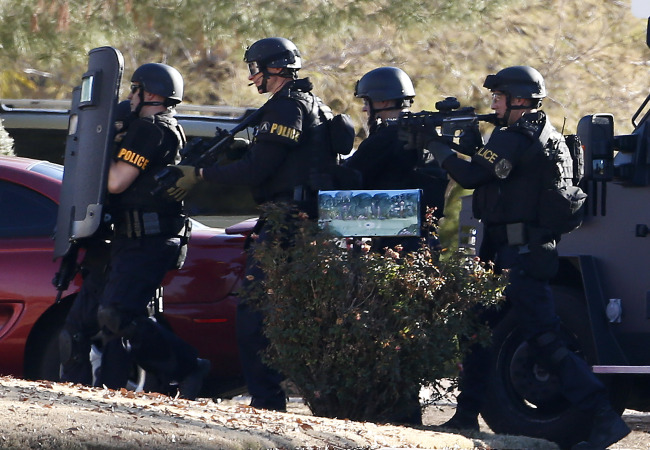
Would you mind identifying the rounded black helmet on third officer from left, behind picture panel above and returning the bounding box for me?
[354,67,415,102]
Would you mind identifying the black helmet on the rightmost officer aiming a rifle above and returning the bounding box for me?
[483,66,546,99]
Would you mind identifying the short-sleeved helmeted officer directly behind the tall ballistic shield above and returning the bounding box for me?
[93,63,210,399]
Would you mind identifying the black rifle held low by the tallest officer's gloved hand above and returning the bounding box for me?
[152,108,262,195]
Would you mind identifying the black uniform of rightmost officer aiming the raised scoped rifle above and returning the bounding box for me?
[442,111,608,422]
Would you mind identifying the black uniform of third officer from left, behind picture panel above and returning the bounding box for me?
[343,120,448,251]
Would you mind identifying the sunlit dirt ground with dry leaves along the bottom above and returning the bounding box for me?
[0,377,650,450]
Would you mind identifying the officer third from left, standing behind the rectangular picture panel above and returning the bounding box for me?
[343,67,448,251]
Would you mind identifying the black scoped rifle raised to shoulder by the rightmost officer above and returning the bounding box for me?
[397,97,497,153]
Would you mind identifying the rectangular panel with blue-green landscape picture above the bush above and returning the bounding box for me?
[318,189,421,237]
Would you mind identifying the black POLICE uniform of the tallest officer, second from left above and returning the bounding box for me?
[203,78,335,410]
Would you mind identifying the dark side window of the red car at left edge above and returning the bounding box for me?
[0,181,57,238]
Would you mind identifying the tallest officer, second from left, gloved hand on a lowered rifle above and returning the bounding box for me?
[168,37,335,410]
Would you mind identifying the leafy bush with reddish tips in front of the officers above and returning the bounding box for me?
[246,205,504,421]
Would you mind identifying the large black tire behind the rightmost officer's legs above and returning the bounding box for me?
[482,287,595,447]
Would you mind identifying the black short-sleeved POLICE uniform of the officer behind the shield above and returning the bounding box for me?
[60,112,197,388]
